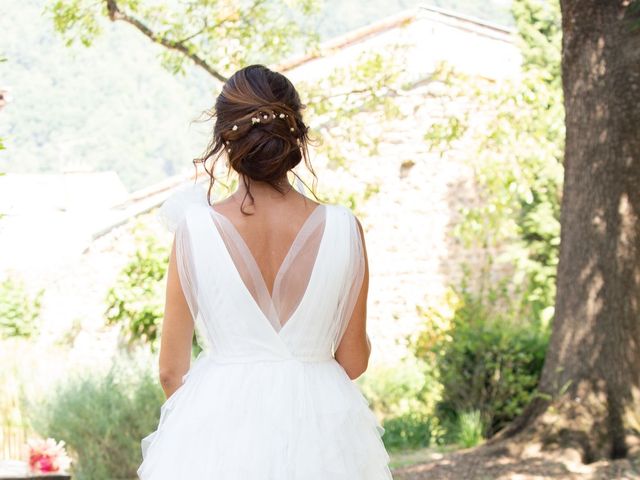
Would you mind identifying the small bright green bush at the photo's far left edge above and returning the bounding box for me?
[0,277,44,338]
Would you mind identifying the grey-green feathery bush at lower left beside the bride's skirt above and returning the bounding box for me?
[29,360,164,480]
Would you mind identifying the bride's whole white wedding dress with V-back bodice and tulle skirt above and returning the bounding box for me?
[138,185,392,480]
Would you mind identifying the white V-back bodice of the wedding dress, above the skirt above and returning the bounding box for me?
[160,185,364,362]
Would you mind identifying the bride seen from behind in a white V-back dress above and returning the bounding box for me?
[138,65,392,480]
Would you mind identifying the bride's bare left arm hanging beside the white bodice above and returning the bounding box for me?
[160,237,194,398]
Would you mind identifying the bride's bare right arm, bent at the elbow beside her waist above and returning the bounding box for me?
[335,219,371,380]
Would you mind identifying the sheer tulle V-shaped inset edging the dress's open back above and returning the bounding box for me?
[209,205,327,332]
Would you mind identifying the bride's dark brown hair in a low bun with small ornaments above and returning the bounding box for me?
[193,65,317,214]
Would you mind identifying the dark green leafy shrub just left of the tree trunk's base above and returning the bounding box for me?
[412,279,549,438]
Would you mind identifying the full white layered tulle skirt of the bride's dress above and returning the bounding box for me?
[138,354,392,480]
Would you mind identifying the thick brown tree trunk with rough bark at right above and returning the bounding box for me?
[499,0,640,463]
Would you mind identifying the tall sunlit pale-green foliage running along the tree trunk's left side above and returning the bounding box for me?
[425,0,564,336]
